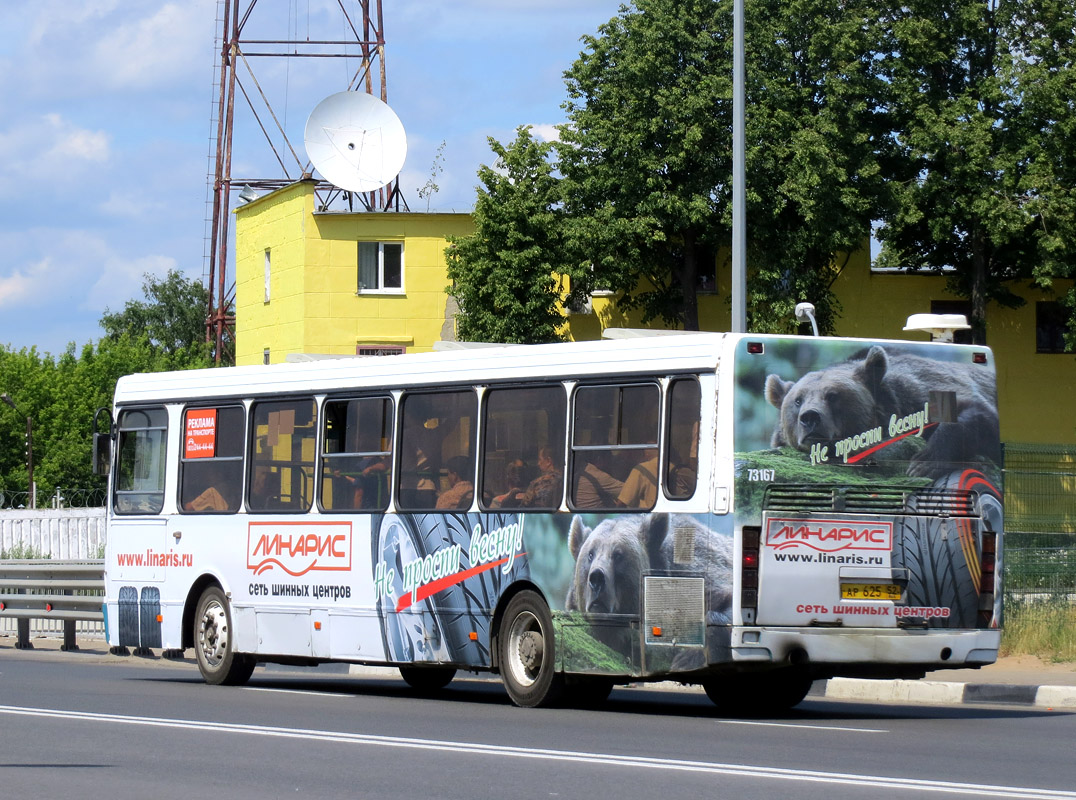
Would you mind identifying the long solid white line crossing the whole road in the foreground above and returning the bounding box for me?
[0,705,1076,800]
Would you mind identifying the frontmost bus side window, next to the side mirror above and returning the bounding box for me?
[112,408,168,514]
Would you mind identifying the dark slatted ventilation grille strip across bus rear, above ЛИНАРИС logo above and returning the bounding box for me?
[763,483,979,517]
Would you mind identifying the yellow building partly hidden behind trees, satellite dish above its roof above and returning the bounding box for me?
[236,181,1076,445]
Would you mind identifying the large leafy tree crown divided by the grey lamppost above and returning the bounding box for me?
[560,0,883,331]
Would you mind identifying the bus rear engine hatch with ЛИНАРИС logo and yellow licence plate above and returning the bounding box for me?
[756,487,993,629]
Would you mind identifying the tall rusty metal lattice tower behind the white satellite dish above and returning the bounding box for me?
[204,0,408,363]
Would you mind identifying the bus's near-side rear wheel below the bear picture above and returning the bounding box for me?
[497,590,564,708]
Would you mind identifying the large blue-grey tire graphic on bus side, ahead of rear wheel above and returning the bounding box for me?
[373,514,527,665]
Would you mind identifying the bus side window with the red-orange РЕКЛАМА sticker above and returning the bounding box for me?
[180,406,246,514]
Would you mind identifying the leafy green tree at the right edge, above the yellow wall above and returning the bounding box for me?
[878,0,1076,342]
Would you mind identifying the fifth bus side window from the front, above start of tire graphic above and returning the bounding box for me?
[396,389,478,511]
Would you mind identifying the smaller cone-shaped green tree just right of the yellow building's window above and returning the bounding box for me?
[445,126,571,343]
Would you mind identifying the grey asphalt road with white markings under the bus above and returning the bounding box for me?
[0,648,1076,800]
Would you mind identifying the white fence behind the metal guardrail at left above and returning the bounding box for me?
[0,508,105,636]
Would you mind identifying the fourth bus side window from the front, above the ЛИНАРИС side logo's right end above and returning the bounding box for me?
[321,397,393,511]
